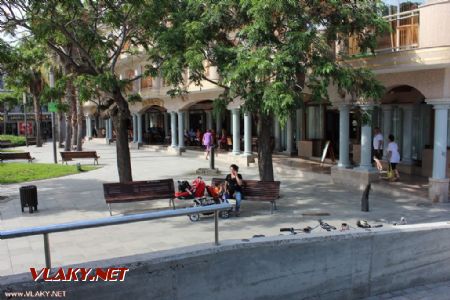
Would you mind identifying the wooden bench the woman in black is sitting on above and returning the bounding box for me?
[211,178,280,214]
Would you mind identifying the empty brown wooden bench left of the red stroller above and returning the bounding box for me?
[103,179,175,216]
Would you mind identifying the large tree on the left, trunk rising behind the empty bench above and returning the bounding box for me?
[0,0,158,182]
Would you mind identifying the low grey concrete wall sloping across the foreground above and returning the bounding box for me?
[0,223,450,300]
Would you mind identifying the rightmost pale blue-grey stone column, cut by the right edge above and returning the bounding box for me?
[426,99,450,202]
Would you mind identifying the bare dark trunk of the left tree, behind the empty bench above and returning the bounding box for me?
[112,88,133,183]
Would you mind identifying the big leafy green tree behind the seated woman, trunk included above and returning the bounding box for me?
[145,0,387,180]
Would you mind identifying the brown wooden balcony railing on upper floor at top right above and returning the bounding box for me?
[344,9,419,56]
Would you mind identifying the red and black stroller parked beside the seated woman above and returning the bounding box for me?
[175,176,229,222]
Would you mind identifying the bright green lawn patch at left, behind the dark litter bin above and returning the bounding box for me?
[0,163,98,184]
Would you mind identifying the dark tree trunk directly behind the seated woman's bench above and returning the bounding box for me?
[258,113,274,181]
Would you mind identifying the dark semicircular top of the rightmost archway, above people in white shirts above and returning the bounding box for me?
[380,84,425,104]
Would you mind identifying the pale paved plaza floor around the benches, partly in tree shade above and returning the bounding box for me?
[0,139,450,299]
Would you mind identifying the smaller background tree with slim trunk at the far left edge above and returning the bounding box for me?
[0,39,47,147]
